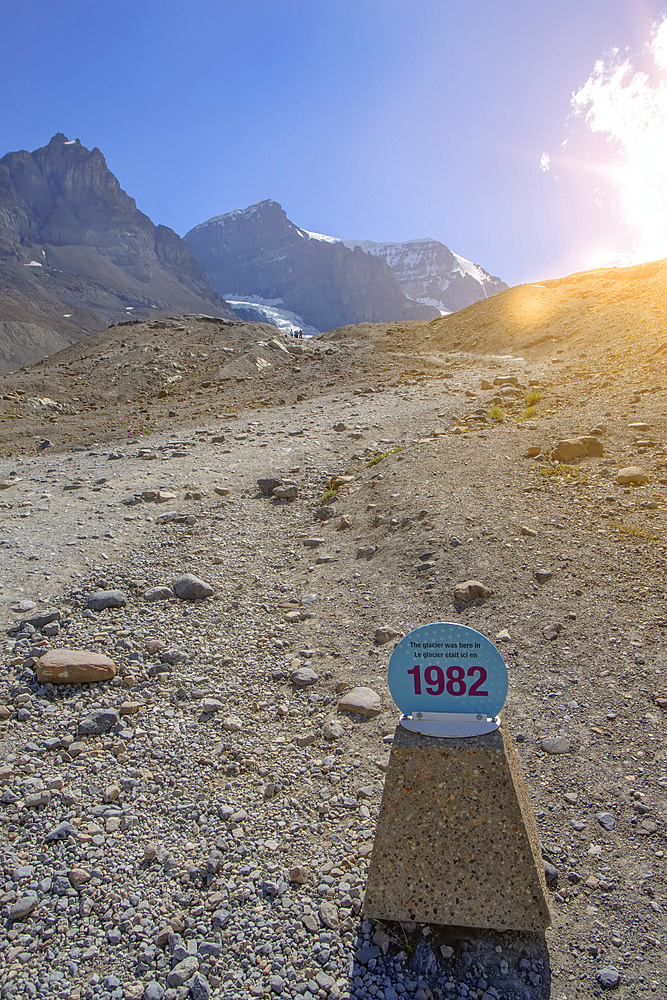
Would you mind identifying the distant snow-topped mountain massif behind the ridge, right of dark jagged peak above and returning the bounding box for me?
[184,200,507,332]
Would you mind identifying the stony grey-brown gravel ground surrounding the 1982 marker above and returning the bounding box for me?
[0,346,667,1000]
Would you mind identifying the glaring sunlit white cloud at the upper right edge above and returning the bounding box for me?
[572,17,667,263]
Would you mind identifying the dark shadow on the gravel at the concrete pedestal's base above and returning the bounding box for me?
[343,920,551,1000]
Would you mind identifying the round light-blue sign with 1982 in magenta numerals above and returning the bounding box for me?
[388,622,507,718]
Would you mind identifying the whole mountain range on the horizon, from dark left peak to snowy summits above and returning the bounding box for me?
[0,132,506,372]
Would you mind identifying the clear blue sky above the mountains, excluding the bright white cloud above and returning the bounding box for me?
[0,0,667,284]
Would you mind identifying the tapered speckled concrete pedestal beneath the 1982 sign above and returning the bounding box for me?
[364,725,550,932]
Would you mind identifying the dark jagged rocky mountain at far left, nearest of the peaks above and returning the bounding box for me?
[0,132,234,367]
